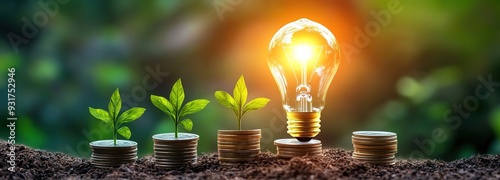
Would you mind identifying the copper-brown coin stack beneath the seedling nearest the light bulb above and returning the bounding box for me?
[217,129,261,165]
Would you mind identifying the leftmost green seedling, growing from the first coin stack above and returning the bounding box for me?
[89,88,146,145]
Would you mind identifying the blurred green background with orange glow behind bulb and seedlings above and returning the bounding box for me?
[0,0,500,160]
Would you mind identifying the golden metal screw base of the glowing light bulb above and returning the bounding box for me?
[286,112,321,142]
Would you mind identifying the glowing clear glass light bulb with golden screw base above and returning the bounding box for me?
[268,18,340,142]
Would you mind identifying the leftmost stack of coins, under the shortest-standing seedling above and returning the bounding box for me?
[90,140,137,168]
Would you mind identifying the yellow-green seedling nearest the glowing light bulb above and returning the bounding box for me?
[215,75,270,130]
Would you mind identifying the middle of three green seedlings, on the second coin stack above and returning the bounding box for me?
[151,78,210,138]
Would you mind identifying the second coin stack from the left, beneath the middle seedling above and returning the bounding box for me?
[153,133,199,169]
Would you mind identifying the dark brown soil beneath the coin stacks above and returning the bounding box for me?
[0,140,500,179]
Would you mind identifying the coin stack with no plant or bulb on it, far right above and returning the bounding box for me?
[352,131,398,165]
